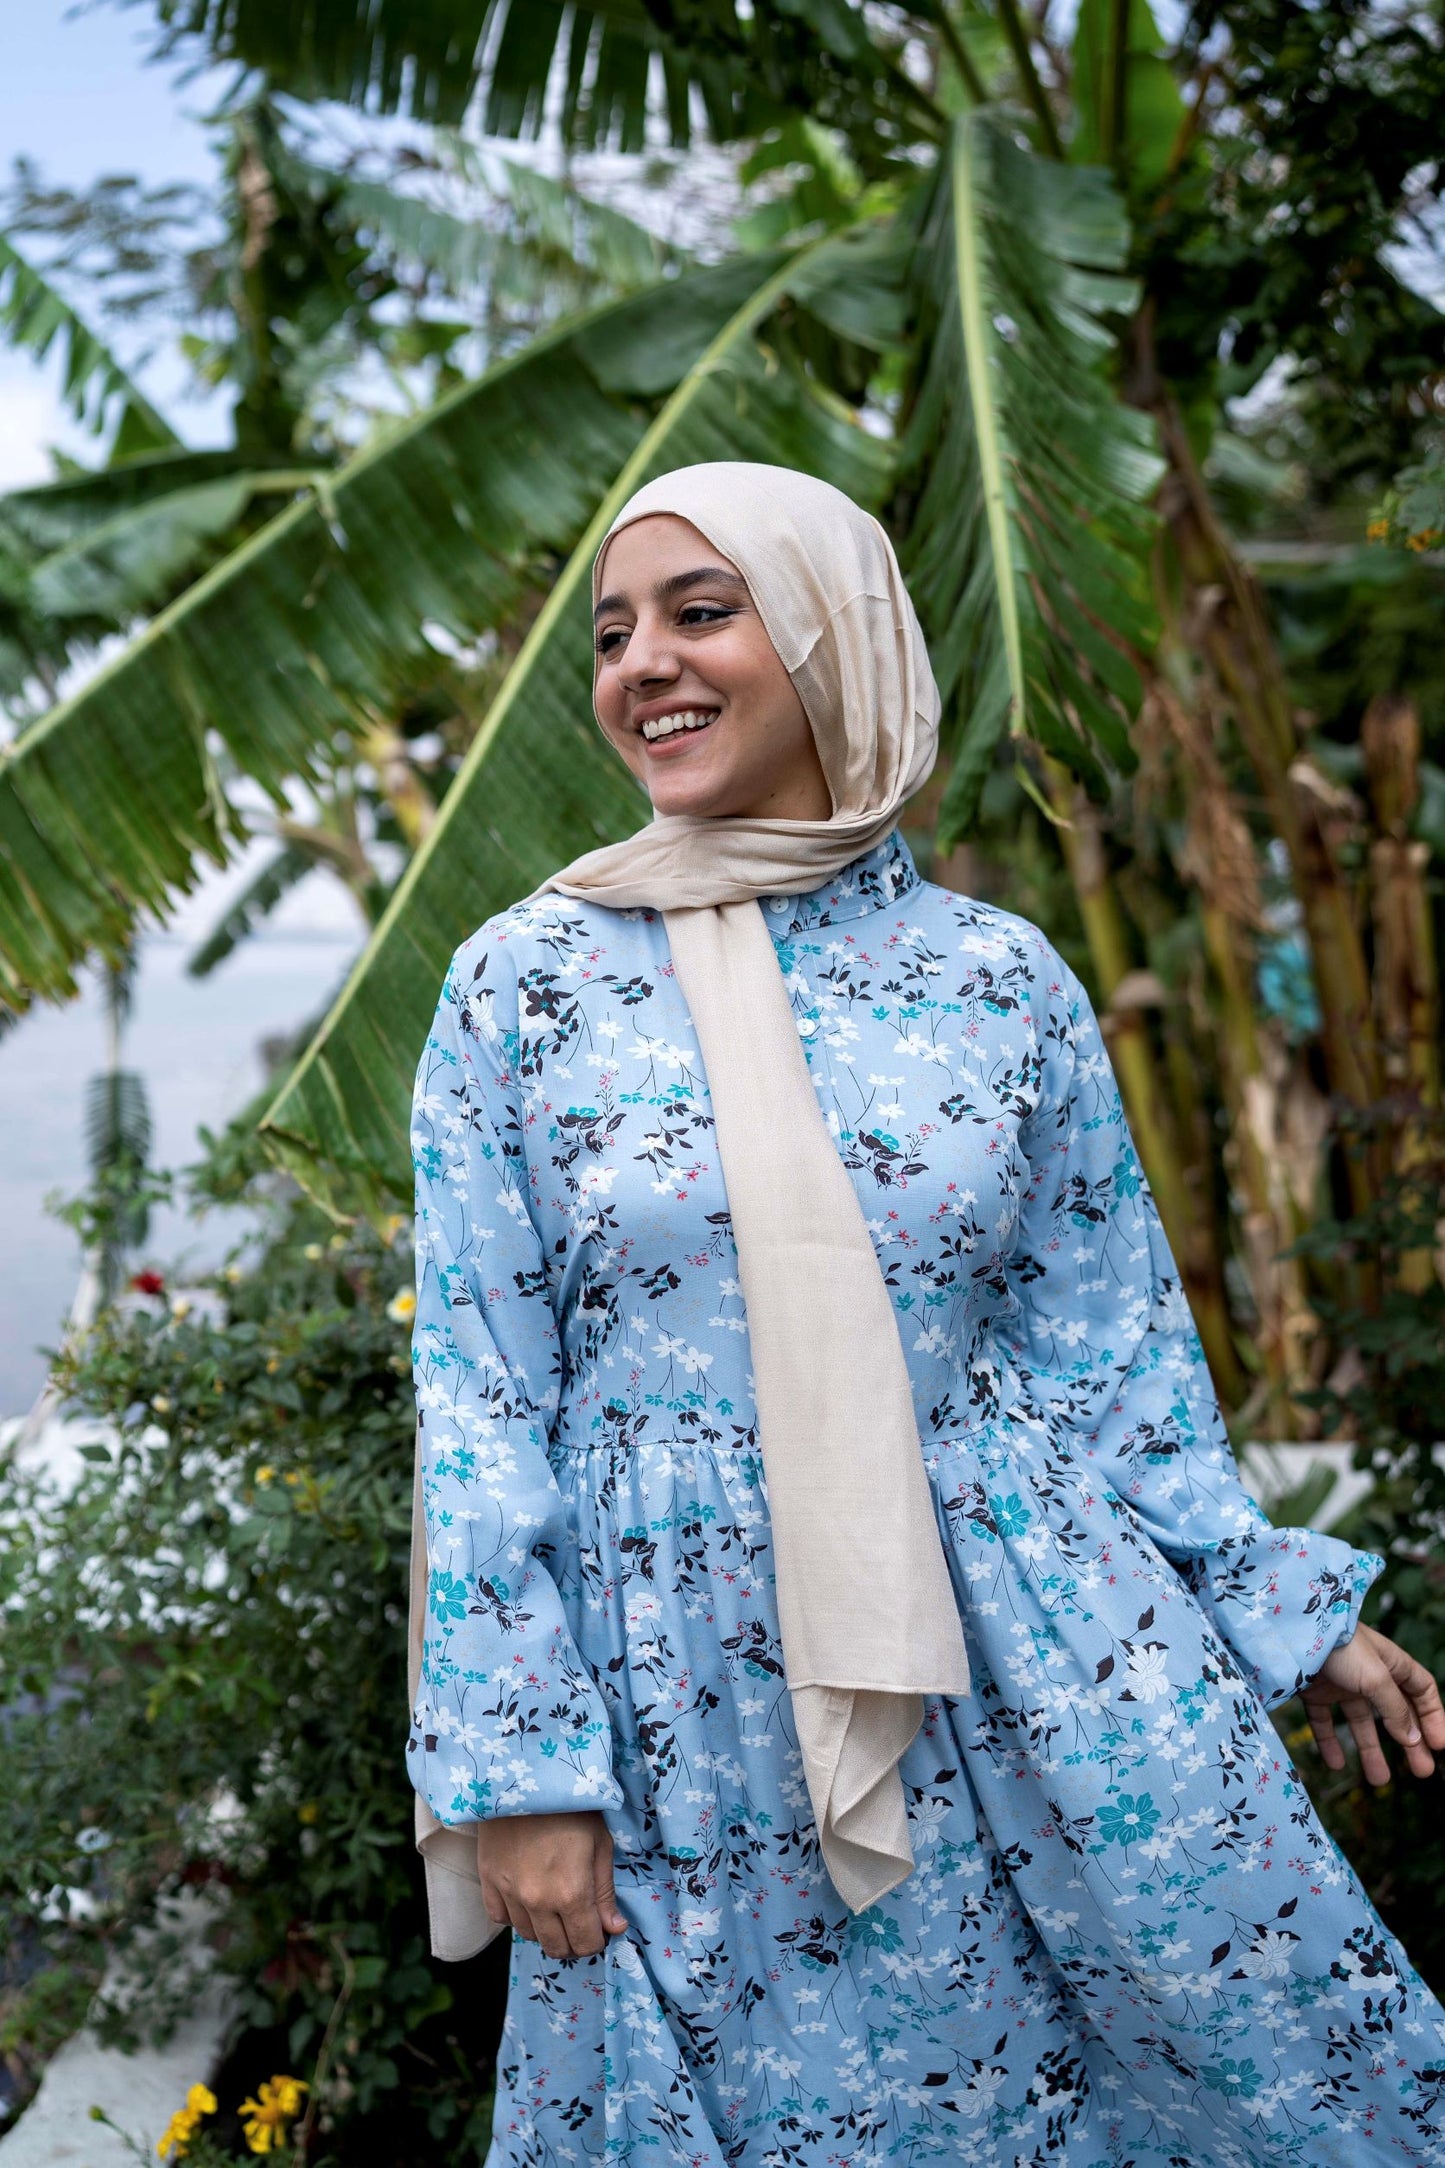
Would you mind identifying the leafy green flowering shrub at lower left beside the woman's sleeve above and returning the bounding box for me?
[0,1205,509,2168]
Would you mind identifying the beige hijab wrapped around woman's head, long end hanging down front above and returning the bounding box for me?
[412,462,968,1956]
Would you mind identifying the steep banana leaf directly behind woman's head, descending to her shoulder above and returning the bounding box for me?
[262,234,890,1205]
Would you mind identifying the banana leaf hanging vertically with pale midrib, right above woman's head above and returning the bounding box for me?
[901,108,1161,843]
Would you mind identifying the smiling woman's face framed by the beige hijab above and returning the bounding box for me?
[596,512,832,820]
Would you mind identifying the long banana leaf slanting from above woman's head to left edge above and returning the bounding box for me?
[0,258,792,1004]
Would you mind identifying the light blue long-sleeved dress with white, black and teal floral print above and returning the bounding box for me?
[409,830,1445,2168]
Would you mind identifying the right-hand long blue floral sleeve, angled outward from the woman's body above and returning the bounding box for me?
[1003,943,1384,1704]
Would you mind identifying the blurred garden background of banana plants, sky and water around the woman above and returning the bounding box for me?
[0,0,1445,2168]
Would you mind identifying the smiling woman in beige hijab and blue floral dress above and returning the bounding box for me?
[409,466,1445,2168]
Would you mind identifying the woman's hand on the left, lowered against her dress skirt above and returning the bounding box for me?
[477,1815,626,1958]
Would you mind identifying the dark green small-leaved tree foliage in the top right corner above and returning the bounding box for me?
[1137,0,1445,472]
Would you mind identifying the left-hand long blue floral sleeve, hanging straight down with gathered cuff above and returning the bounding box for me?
[407,928,622,1823]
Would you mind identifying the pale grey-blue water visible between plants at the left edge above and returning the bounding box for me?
[0,934,355,1418]
